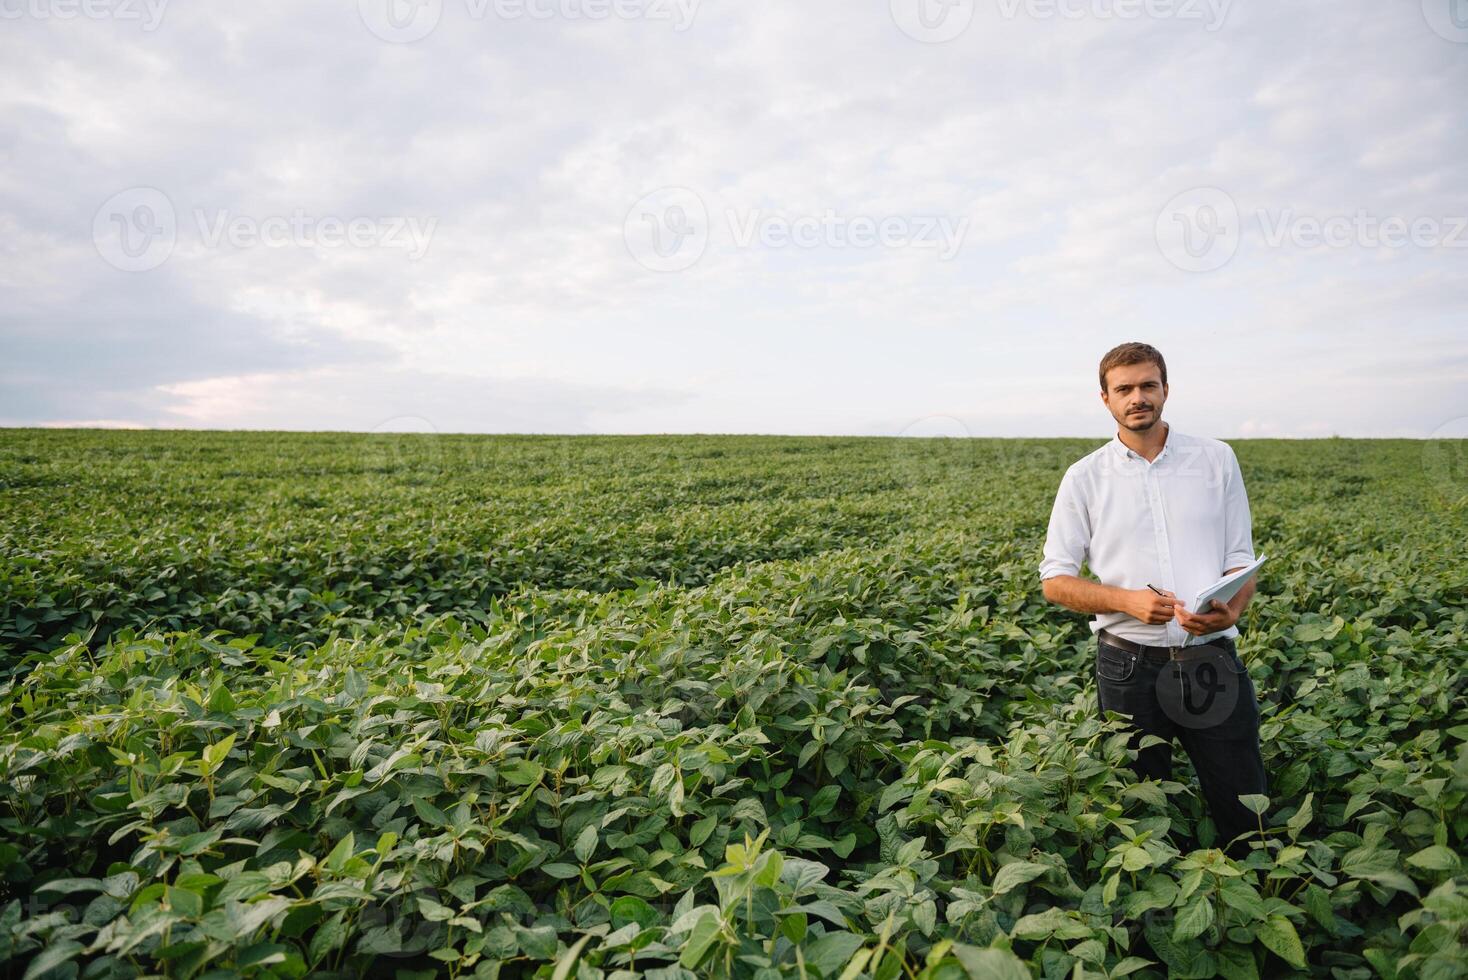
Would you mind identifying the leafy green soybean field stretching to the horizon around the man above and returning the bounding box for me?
[0,430,1468,980]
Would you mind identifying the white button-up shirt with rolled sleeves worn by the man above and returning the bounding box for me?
[1039,423,1254,647]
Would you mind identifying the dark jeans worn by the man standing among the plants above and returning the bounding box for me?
[1095,637,1268,858]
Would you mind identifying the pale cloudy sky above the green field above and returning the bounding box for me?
[0,0,1468,439]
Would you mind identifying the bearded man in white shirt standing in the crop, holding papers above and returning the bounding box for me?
[1039,343,1267,858]
